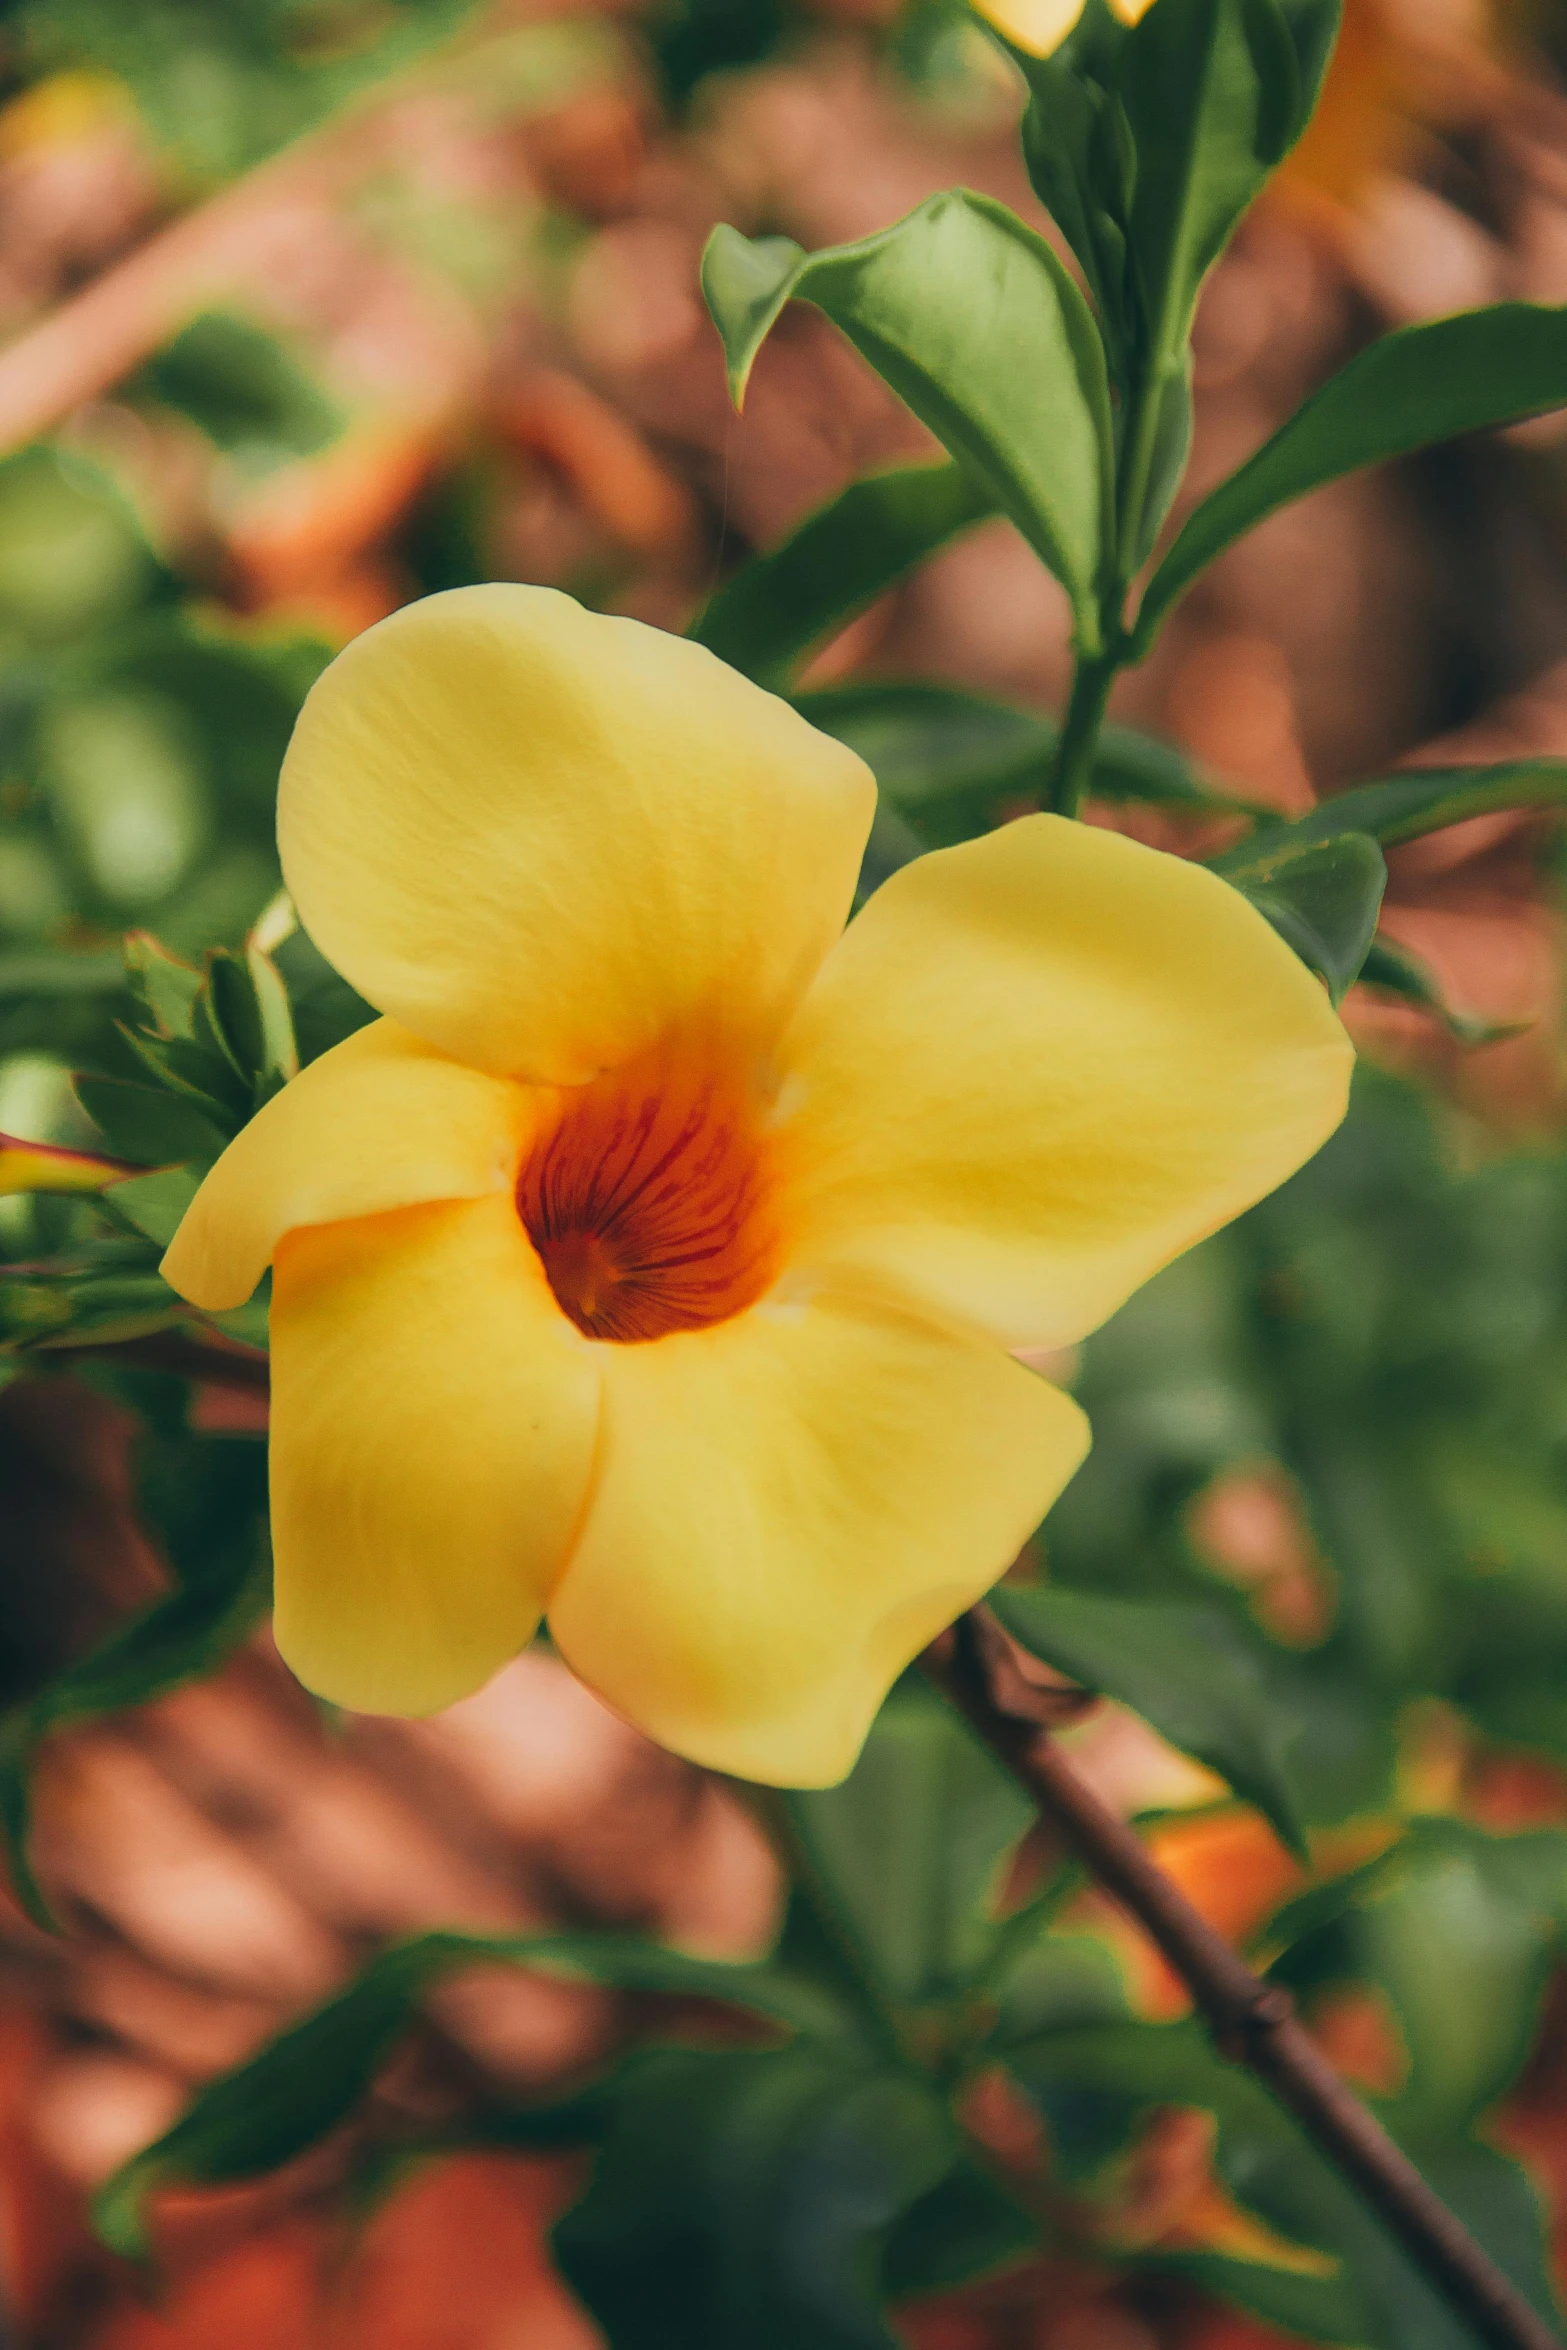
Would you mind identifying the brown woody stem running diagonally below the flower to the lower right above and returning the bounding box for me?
[921,1607,1560,2350]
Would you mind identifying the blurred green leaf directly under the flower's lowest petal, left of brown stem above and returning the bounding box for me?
[782,1680,1034,2002]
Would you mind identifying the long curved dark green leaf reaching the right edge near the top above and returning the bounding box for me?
[1132,307,1567,658]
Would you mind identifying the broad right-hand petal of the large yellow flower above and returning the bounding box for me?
[780,815,1353,1347]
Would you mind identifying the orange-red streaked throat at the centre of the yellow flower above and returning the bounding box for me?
[517,1055,778,1344]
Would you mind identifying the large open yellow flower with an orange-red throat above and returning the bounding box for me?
[164,588,1351,1786]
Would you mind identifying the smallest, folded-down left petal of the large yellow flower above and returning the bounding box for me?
[162,1020,536,1314]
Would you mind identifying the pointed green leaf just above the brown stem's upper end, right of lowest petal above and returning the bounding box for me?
[989,1584,1306,1852]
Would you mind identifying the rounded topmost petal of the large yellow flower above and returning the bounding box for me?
[277,585,876,1083]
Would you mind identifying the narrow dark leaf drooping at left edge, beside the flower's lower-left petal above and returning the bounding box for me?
[0,1485,273,1927]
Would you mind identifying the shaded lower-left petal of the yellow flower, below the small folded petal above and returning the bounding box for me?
[273,1199,599,1713]
